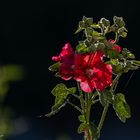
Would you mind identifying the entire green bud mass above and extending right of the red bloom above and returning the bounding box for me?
[76,16,140,74]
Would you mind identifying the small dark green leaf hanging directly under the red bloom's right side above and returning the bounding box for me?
[99,90,113,106]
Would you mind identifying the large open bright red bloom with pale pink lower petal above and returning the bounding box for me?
[74,51,112,92]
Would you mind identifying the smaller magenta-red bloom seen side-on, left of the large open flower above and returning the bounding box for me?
[52,43,74,80]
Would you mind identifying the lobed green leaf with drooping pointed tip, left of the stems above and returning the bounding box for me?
[46,83,76,116]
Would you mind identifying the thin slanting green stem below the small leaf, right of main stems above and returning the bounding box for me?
[98,104,109,132]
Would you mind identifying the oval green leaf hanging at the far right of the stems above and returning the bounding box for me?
[113,93,131,122]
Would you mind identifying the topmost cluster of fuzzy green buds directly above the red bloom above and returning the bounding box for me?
[76,16,127,53]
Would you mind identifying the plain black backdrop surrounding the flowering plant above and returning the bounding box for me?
[0,0,140,140]
